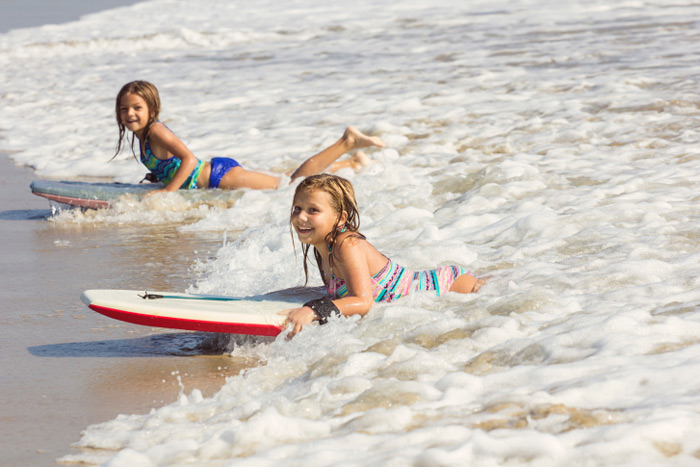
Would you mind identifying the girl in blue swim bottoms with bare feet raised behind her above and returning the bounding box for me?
[115,81,384,194]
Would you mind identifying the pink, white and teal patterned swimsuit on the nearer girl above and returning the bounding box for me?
[321,236,468,303]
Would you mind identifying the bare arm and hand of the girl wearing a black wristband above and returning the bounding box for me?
[280,237,374,336]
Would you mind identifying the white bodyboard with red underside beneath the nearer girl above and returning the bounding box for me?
[81,289,304,336]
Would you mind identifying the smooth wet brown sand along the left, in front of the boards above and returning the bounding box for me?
[0,154,255,466]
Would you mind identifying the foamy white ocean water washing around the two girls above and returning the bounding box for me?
[0,0,700,466]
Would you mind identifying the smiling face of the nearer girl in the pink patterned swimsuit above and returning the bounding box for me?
[291,190,347,251]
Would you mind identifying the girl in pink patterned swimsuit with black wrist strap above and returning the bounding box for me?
[281,174,484,335]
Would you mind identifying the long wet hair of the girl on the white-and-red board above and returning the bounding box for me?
[289,174,364,286]
